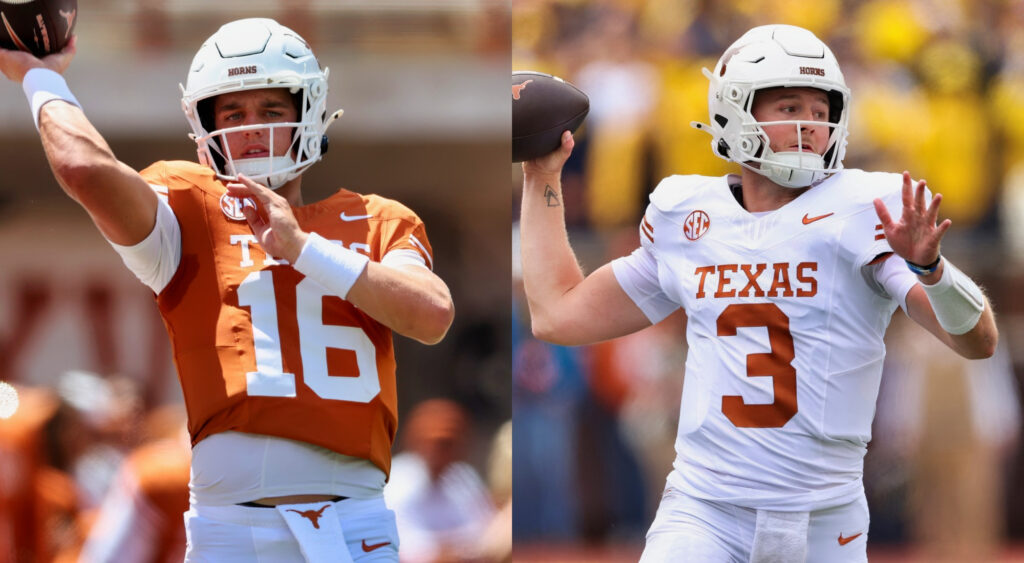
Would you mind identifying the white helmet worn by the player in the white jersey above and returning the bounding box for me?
[691,25,850,187]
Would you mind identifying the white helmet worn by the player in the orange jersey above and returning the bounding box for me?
[181,17,342,189]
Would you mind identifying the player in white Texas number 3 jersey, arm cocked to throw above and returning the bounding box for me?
[520,25,997,562]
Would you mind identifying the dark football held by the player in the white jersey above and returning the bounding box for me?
[512,71,590,162]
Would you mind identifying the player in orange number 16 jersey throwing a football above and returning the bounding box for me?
[0,18,454,561]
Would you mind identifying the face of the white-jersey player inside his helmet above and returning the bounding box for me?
[751,88,828,155]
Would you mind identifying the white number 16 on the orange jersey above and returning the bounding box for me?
[238,270,381,402]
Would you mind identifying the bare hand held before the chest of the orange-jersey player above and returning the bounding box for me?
[227,174,309,264]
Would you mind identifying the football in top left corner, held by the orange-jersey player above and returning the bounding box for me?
[0,0,78,56]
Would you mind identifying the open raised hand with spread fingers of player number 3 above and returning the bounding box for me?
[874,171,952,265]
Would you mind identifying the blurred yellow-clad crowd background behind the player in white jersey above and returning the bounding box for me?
[511,0,1024,562]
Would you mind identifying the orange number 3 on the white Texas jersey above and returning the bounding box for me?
[718,303,797,428]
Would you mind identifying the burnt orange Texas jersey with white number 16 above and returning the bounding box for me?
[142,162,433,473]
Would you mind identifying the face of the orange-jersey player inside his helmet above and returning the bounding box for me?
[213,88,298,160]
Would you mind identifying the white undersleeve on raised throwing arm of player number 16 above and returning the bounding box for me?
[108,185,181,295]
